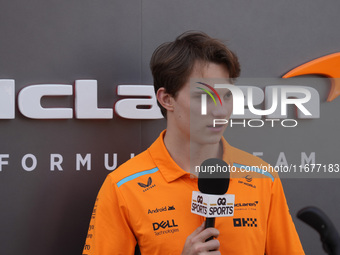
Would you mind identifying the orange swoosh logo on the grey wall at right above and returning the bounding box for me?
[282,52,340,102]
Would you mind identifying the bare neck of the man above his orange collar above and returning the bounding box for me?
[164,131,223,174]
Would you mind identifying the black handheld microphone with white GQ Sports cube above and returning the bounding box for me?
[191,158,235,241]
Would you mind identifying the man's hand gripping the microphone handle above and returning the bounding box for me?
[182,222,221,255]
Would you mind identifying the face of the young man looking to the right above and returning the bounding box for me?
[174,63,233,145]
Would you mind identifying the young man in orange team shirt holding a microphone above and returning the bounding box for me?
[84,33,304,255]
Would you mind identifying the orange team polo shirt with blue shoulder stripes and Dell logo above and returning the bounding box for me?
[83,131,304,255]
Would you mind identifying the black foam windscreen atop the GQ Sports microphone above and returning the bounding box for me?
[198,158,230,195]
